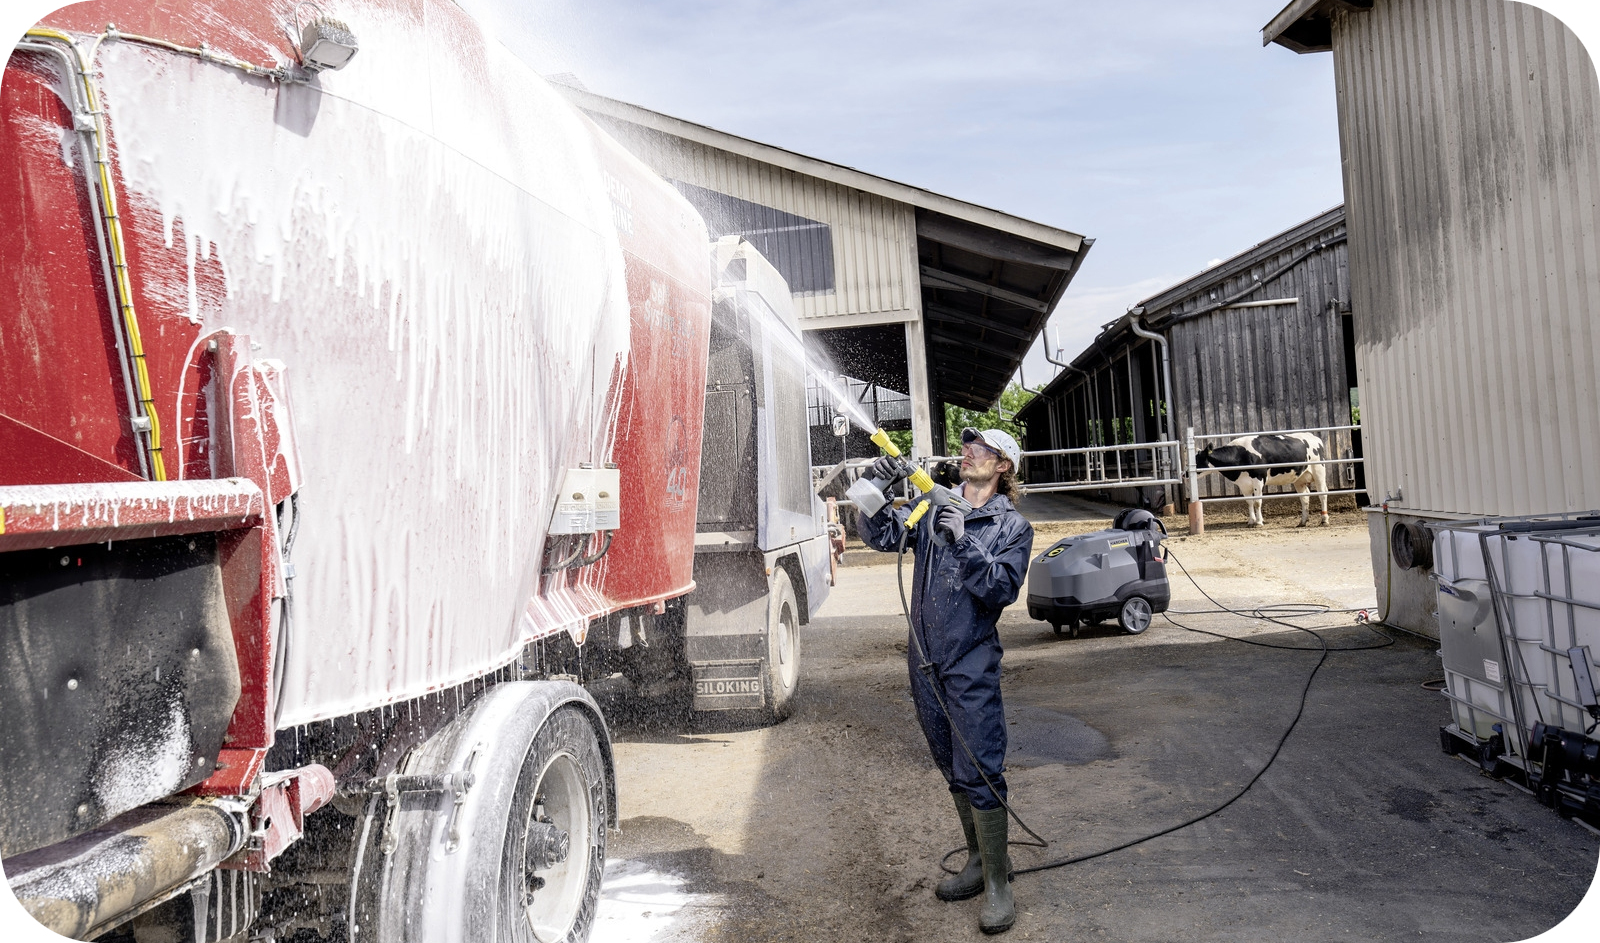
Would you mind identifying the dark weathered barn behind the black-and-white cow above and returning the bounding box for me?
[1018,205,1360,508]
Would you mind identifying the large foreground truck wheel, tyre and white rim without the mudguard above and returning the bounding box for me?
[499,706,606,943]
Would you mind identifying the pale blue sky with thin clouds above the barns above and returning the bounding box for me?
[464,0,1342,384]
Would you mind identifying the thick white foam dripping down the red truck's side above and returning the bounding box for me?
[98,11,649,727]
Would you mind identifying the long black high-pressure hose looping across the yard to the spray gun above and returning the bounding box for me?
[894,525,1395,876]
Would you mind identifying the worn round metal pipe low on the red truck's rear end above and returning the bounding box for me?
[5,799,248,940]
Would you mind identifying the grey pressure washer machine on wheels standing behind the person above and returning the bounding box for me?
[1027,508,1173,637]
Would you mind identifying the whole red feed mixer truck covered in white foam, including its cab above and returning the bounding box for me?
[0,0,830,943]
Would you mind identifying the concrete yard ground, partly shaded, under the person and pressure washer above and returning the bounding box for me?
[594,514,1597,943]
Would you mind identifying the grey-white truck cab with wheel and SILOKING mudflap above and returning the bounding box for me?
[685,235,832,720]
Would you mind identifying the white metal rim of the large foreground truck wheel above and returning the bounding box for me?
[523,752,594,943]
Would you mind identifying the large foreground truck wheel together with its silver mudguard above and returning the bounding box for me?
[371,682,614,943]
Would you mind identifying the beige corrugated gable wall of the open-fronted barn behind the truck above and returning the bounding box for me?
[598,118,922,327]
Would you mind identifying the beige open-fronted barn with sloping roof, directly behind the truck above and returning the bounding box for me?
[555,77,1093,455]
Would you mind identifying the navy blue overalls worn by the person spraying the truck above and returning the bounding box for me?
[858,495,1034,809]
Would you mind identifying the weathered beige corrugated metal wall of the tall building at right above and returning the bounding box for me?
[1333,0,1600,514]
